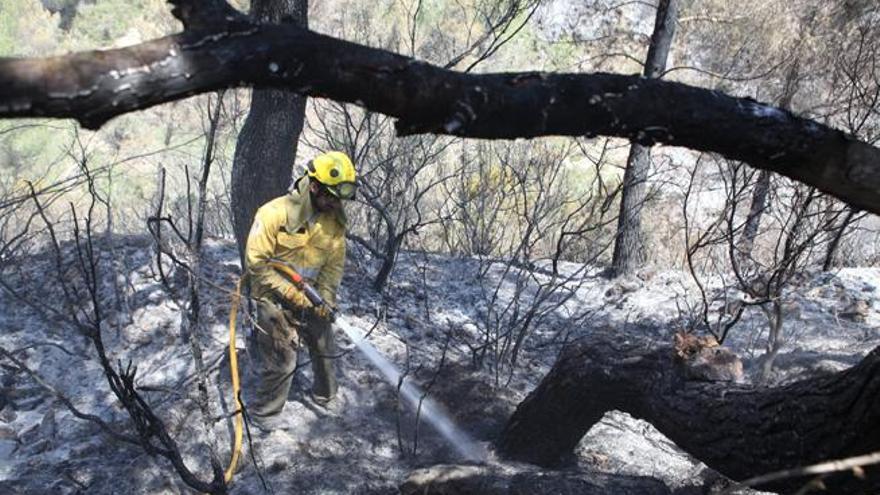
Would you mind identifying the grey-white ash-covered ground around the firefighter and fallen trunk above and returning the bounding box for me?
[0,238,880,494]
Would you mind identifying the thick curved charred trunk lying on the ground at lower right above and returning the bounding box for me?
[499,341,880,493]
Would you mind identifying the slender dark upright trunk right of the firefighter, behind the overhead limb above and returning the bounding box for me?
[611,0,678,277]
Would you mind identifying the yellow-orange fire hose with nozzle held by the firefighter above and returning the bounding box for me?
[223,260,326,483]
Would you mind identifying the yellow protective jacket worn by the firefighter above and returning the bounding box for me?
[245,177,346,306]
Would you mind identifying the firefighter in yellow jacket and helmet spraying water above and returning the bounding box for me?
[245,151,357,430]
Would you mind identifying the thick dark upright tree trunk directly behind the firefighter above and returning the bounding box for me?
[231,0,308,266]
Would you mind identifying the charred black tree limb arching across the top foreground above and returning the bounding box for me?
[0,15,880,213]
